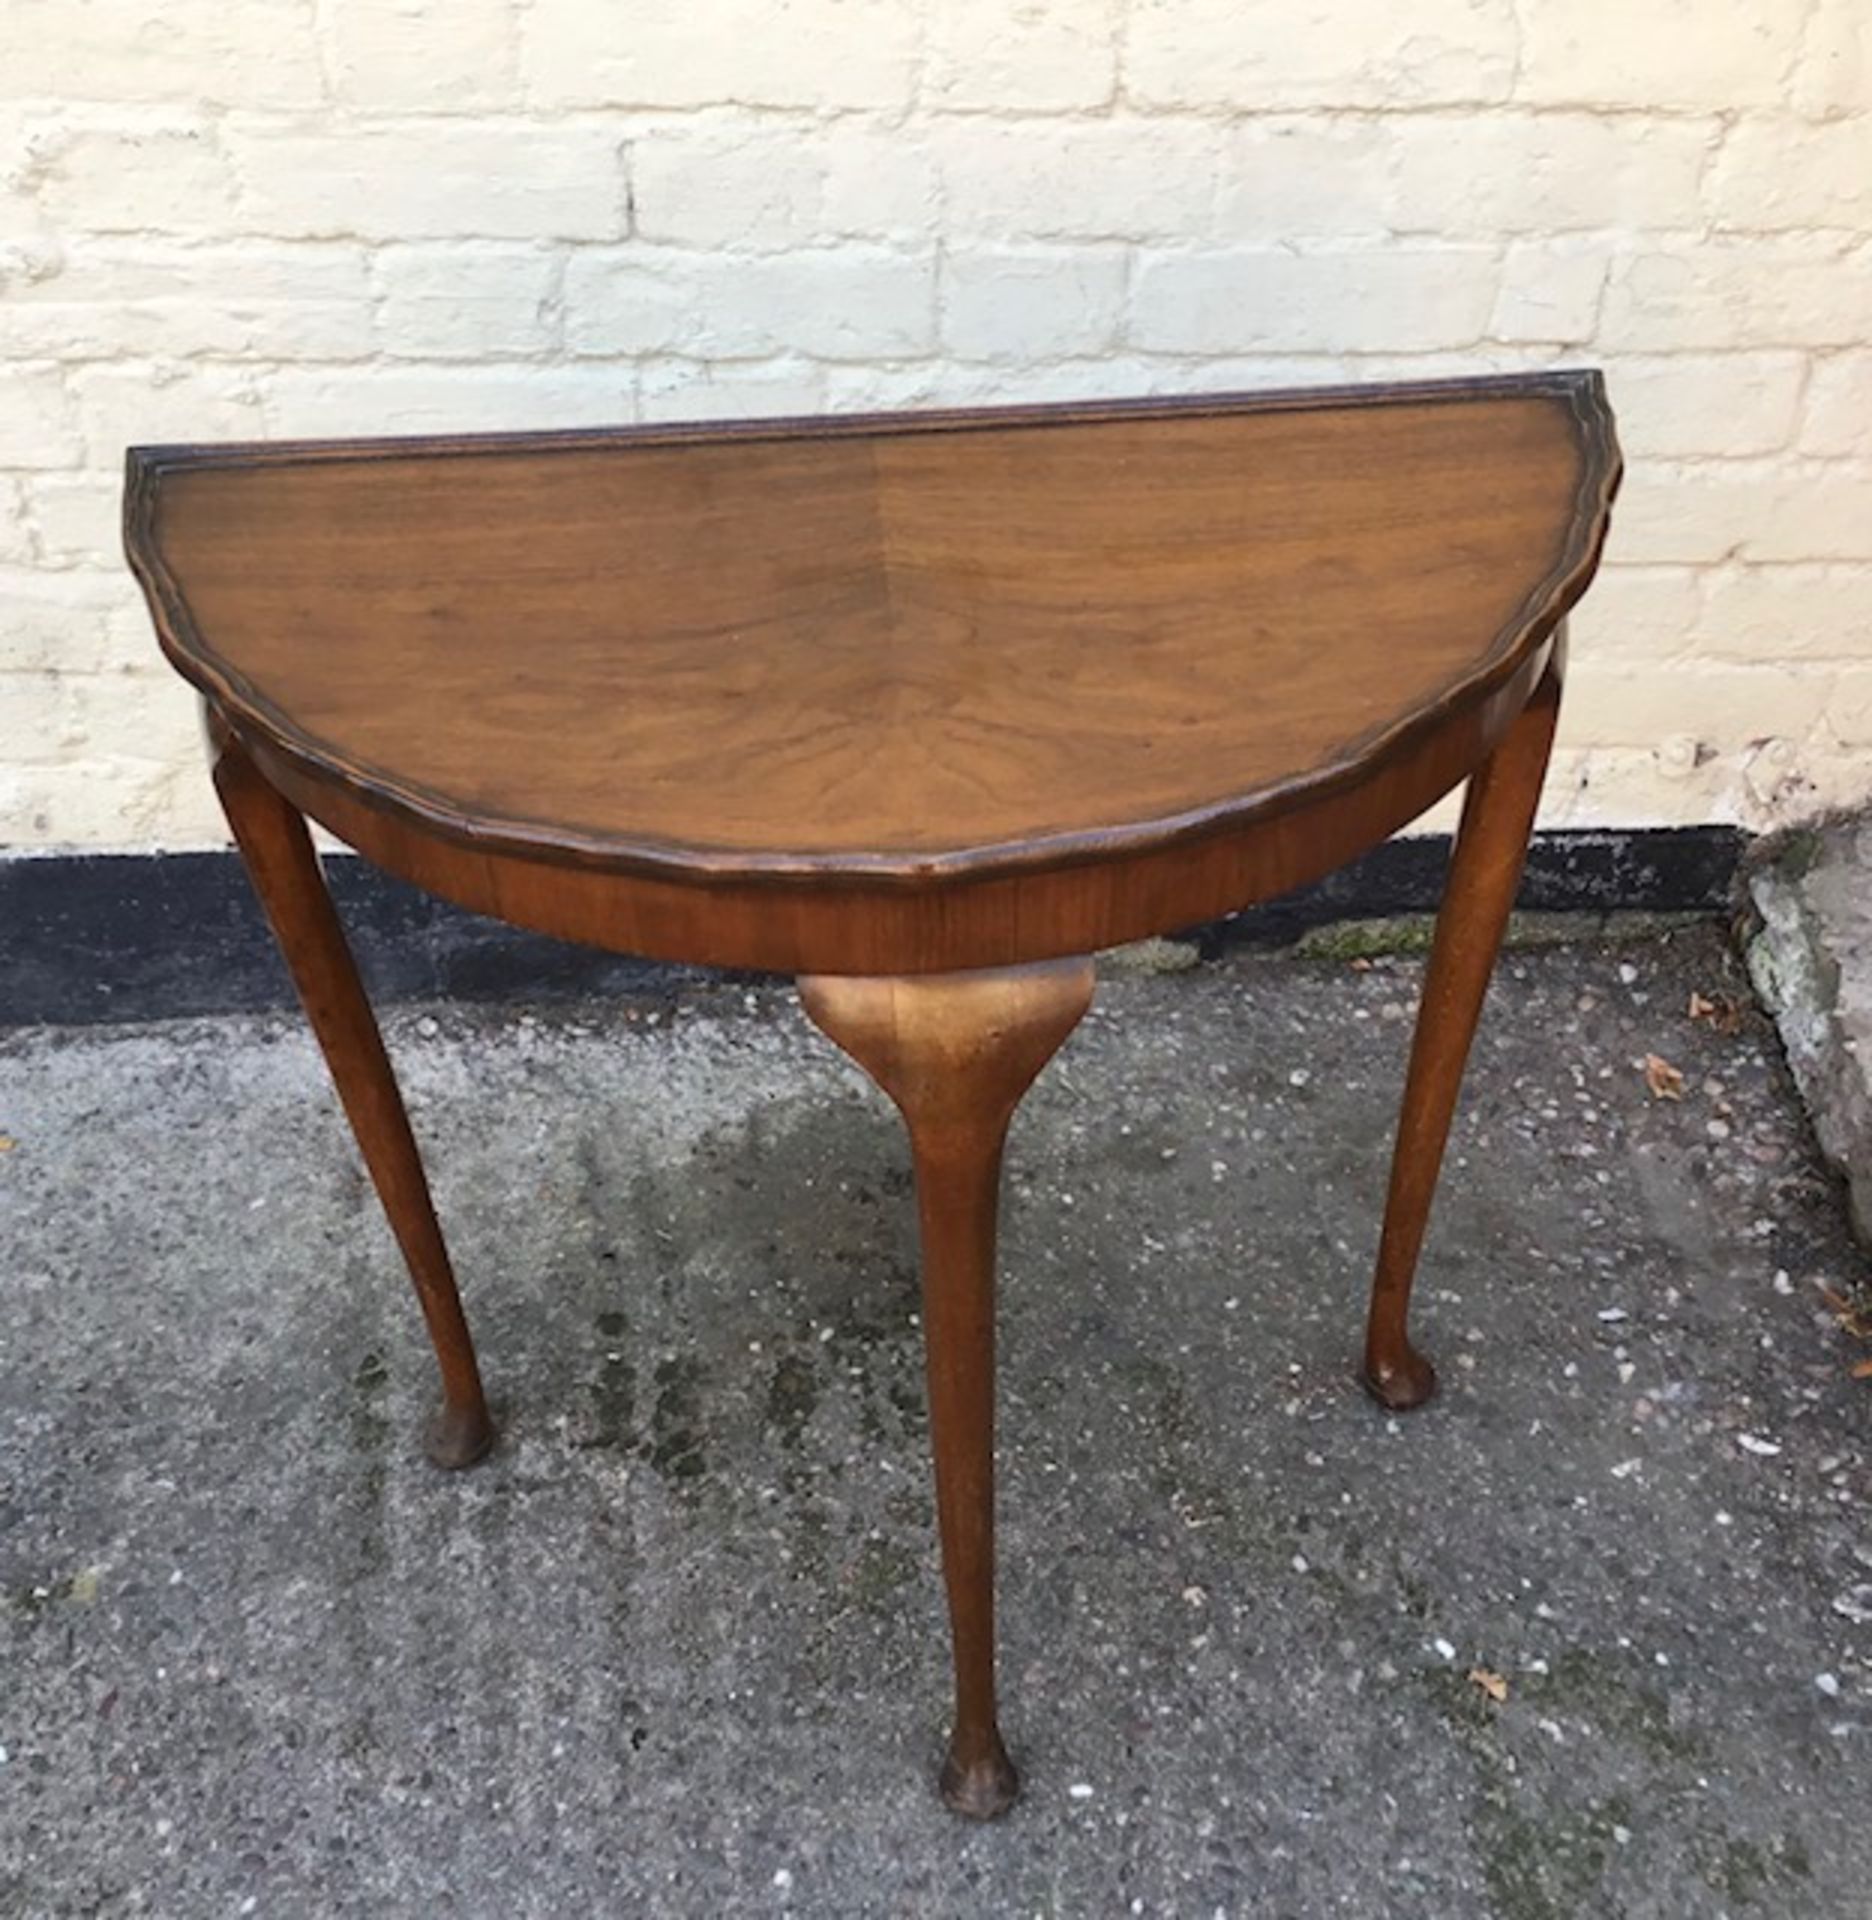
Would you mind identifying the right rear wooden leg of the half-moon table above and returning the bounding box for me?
[1365,636,1565,1411]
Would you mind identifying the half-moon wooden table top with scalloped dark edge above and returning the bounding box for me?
[127,372,1619,881]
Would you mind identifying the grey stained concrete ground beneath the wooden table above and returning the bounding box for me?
[0,927,1872,1920]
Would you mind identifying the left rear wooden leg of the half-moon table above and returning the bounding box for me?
[211,728,493,1467]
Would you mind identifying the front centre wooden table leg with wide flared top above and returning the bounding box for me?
[799,960,1092,1820]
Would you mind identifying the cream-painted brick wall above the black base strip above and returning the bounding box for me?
[0,0,1872,849]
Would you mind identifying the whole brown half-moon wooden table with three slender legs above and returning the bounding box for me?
[125,372,1619,1816]
